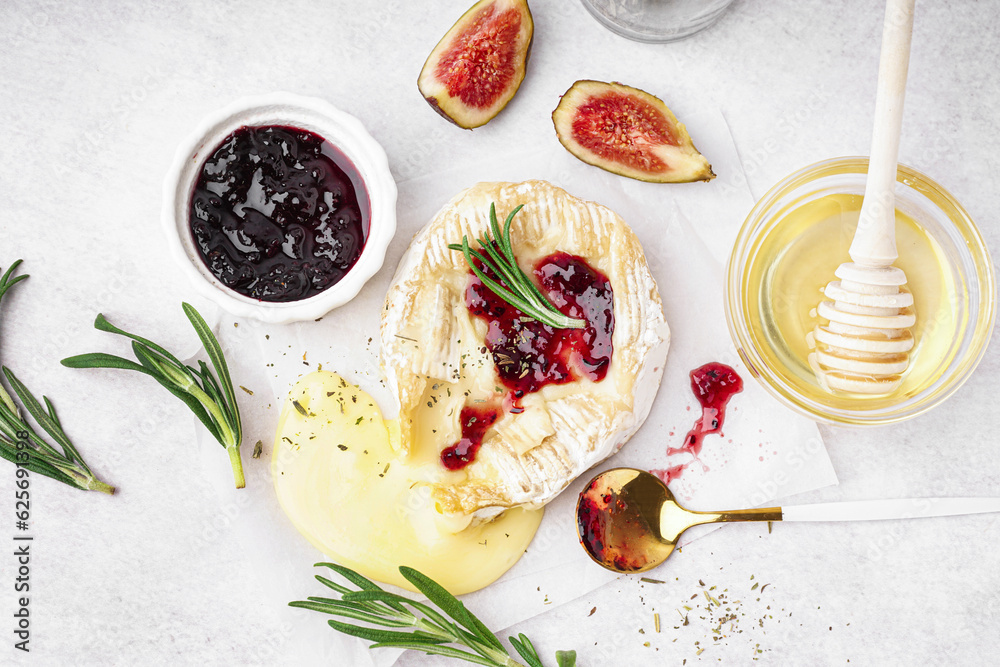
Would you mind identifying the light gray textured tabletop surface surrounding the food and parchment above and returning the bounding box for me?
[0,0,1000,665]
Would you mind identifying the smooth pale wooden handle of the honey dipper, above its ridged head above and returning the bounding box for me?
[850,0,915,266]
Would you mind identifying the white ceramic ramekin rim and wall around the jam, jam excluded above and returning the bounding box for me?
[162,93,396,324]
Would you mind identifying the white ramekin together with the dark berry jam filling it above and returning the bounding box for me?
[163,93,396,323]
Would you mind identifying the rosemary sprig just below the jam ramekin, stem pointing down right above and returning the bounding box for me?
[62,303,246,489]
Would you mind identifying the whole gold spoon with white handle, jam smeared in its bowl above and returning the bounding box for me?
[576,468,1000,572]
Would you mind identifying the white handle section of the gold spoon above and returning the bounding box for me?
[781,498,1000,521]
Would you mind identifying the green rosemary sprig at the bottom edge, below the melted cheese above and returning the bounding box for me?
[288,563,576,667]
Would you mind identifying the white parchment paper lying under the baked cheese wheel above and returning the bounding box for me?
[189,109,836,666]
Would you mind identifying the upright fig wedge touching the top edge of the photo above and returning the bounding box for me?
[417,0,535,130]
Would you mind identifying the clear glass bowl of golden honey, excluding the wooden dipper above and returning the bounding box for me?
[726,157,996,426]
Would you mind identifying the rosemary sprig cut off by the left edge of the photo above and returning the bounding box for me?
[0,260,115,495]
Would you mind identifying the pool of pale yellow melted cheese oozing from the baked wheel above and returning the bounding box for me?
[271,371,542,595]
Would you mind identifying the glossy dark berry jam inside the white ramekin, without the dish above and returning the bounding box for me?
[188,125,370,302]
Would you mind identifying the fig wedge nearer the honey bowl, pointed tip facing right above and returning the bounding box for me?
[552,80,715,183]
